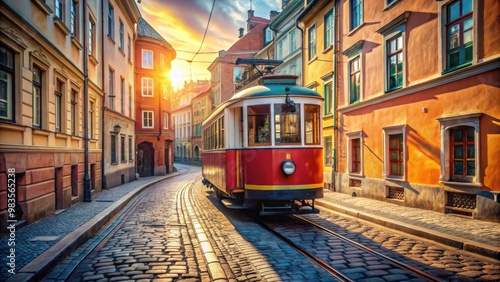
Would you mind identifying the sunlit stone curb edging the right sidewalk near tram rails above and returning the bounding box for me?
[316,200,500,260]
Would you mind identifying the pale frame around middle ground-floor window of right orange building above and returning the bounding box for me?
[382,124,408,181]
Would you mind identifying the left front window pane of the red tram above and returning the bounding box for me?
[248,105,271,146]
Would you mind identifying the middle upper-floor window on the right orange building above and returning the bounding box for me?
[386,34,404,91]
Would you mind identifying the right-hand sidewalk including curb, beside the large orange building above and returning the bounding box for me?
[316,190,500,260]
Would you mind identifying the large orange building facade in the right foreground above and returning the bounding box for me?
[334,0,500,221]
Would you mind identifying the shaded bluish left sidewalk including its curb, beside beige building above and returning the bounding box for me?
[0,172,179,282]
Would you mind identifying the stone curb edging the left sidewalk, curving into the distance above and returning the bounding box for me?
[6,172,180,282]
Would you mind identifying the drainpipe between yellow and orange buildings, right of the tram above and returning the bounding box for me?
[332,0,339,191]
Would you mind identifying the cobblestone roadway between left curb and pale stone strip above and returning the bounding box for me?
[57,173,209,281]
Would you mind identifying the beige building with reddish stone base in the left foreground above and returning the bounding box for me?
[0,1,103,230]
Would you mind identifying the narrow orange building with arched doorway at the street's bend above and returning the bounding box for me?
[135,18,176,176]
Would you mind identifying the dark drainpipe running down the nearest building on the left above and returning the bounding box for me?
[82,0,92,202]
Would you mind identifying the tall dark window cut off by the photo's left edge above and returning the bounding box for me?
[0,45,14,121]
